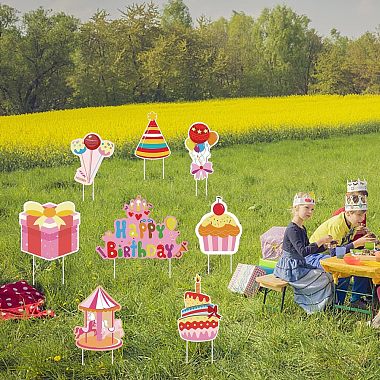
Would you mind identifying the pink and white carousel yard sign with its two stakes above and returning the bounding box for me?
[74,286,124,365]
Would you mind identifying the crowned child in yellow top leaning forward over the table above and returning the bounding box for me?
[306,186,376,309]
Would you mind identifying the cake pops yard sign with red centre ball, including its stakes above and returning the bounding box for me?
[71,133,115,200]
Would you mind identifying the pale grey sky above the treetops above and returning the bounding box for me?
[0,0,380,38]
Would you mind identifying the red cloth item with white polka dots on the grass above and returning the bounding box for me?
[0,281,54,320]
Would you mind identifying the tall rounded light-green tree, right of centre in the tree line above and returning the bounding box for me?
[254,6,321,95]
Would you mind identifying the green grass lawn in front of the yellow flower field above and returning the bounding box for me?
[0,134,380,379]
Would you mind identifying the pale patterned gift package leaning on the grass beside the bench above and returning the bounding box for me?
[228,264,266,297]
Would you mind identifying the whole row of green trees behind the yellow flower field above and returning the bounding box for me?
[0,0,380,115]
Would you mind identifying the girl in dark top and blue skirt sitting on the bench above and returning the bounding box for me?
[274,193,334,314]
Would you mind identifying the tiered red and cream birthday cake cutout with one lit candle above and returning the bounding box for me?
[178,275,221,342]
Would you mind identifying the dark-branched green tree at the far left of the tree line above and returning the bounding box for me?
[2,8,78,113]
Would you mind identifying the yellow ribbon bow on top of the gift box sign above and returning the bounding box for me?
[24,201,75,228]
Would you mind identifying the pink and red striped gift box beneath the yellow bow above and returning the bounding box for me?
[19,203,80,260]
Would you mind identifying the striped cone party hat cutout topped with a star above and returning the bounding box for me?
[135,112,170,160]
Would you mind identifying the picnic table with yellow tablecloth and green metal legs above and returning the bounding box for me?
[321,257,380,316]
